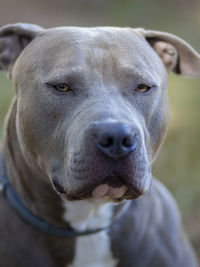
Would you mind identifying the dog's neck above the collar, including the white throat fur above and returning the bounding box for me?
[2,101,122,231]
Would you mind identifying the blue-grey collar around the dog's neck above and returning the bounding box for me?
[0,158,108,238]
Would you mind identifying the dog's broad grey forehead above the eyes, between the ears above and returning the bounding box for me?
[13,27,165,85]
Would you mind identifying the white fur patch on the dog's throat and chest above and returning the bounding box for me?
[63,201,117,267]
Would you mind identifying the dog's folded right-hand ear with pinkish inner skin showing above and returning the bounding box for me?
[138,29,200,77]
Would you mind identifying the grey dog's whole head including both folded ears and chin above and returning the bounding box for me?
[0,24,200,200]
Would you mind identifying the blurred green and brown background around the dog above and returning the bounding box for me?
[0,0,200,262]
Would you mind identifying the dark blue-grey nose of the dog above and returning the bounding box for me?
[95,122,136,160]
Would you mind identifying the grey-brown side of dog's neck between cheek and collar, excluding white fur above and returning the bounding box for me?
[2,102,69,227]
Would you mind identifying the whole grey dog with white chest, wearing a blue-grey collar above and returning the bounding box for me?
[0,23,200,267]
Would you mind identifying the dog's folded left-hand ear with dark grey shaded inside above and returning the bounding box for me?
[0,23,43,73]
